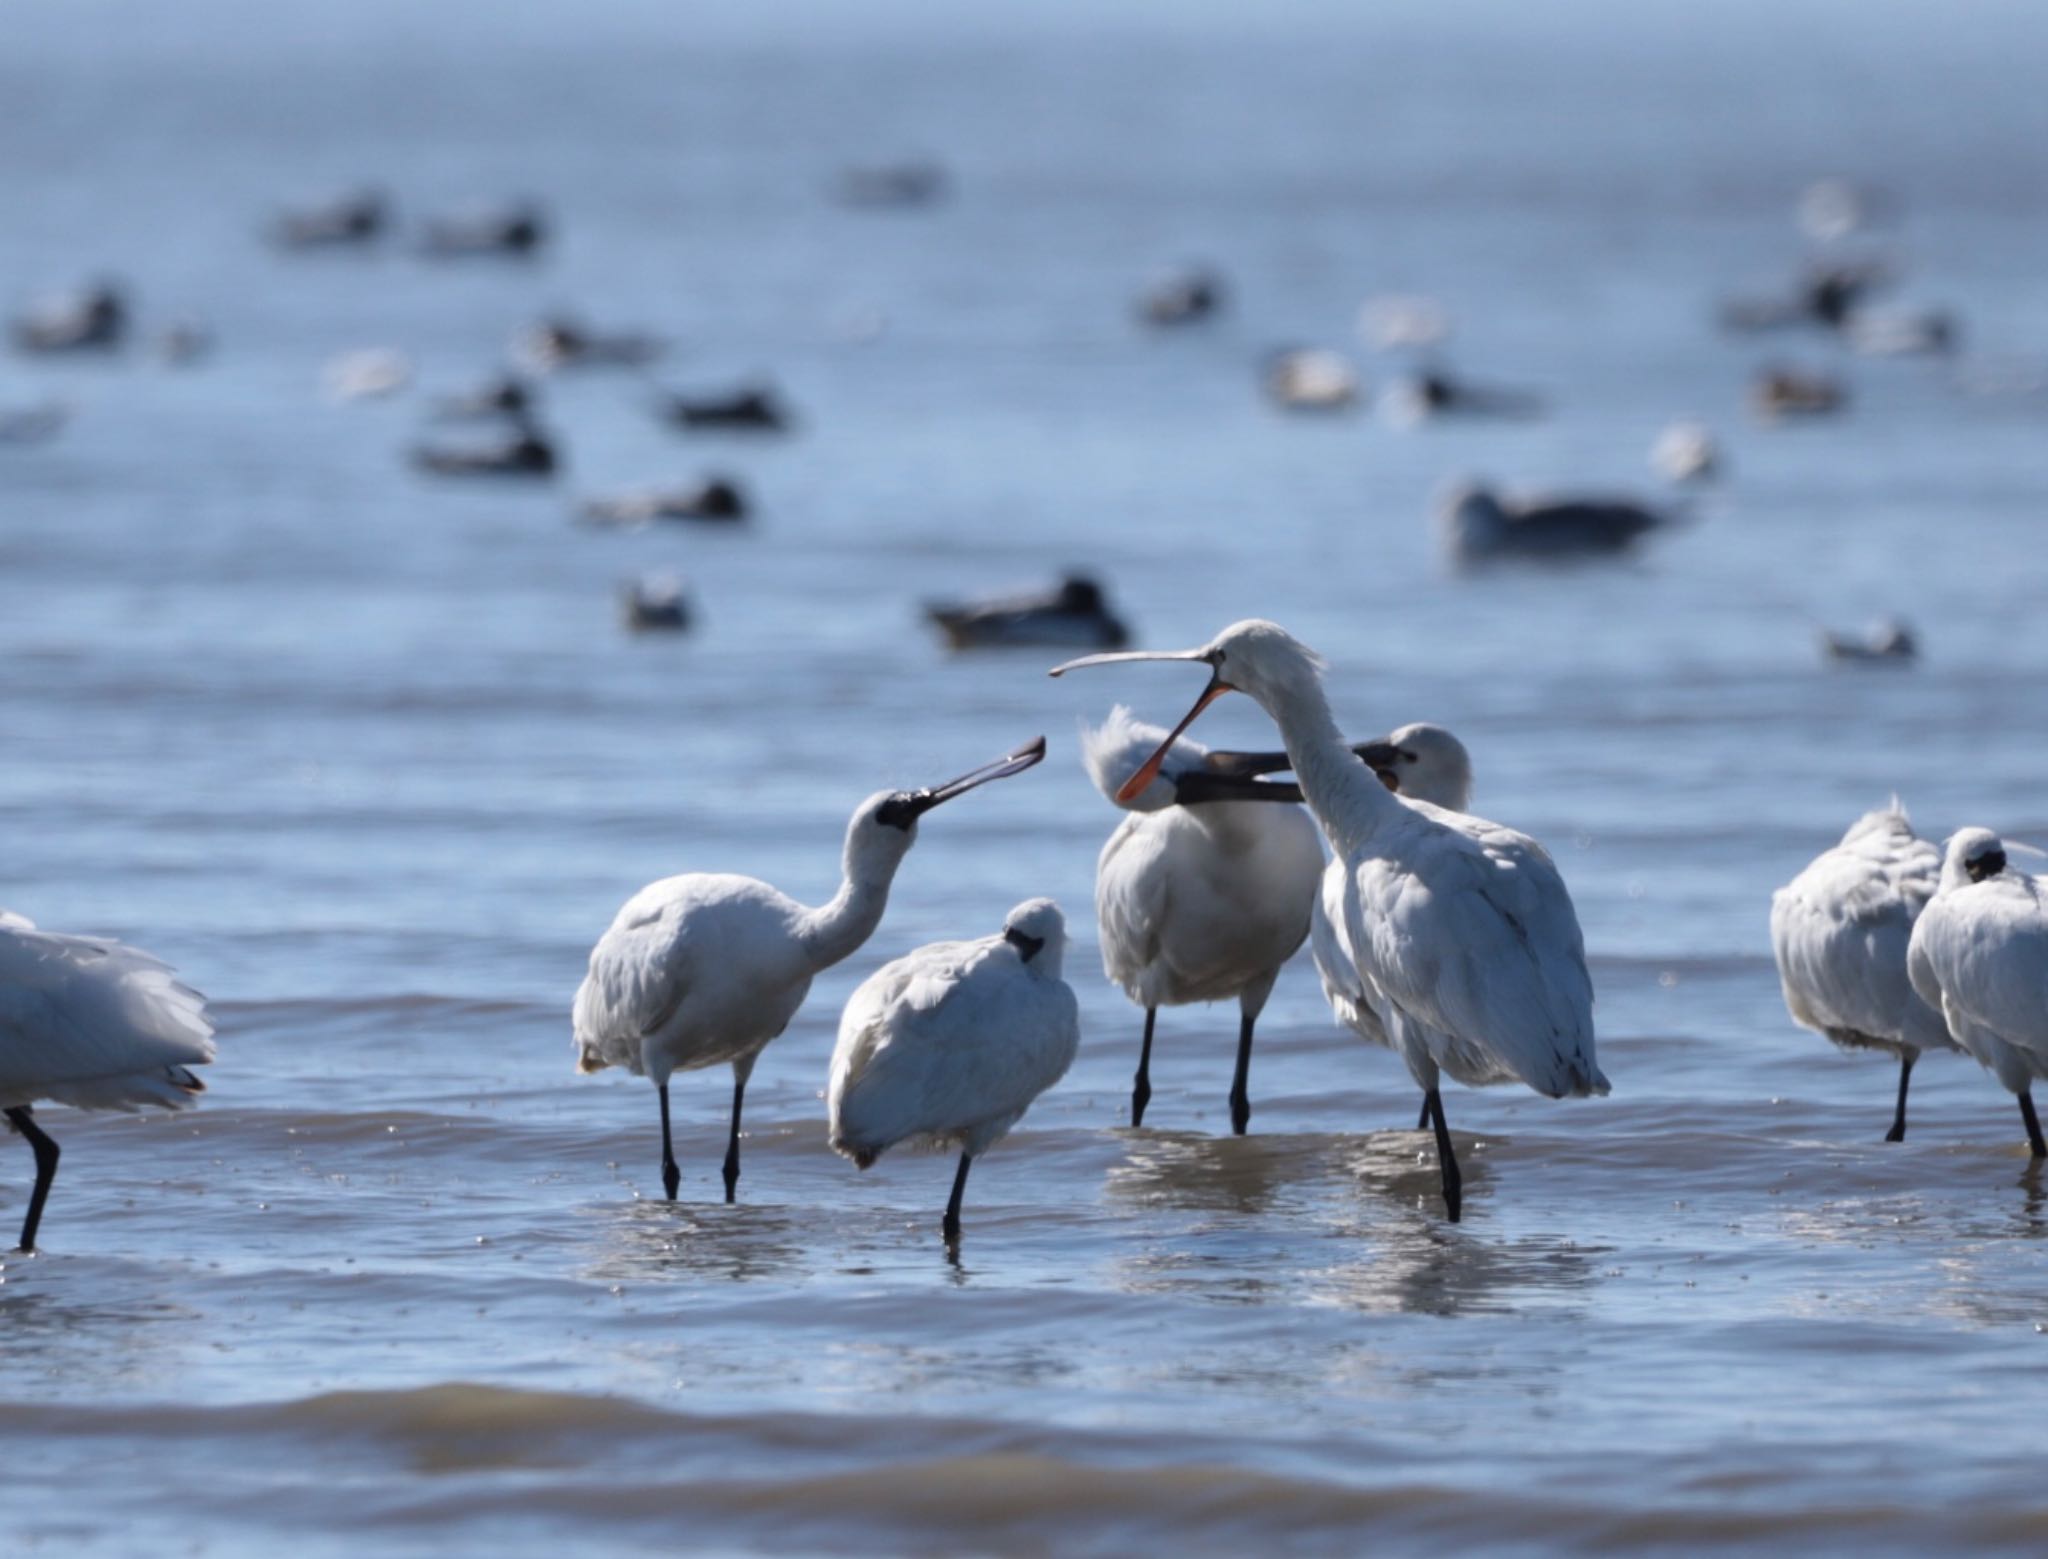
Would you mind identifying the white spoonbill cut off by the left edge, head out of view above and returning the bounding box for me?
[0,910,213,1250]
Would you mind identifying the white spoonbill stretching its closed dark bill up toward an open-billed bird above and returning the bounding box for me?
[575,735,1044,1200]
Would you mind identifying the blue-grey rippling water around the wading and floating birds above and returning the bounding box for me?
[0,0,2048,1559]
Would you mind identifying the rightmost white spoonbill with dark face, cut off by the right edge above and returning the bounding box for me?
[1907,828,2048,1157]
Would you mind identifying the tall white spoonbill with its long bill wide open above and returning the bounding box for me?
[1057,621,1608,1221]
